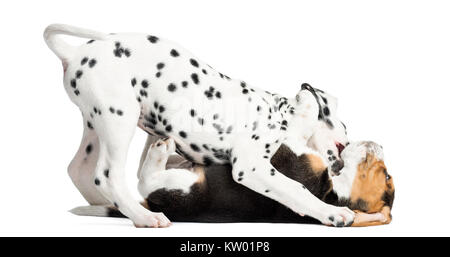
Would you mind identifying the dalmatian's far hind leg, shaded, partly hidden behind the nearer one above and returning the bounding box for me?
[68,121,109,205]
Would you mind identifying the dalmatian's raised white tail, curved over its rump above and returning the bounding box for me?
[44,24,107,63]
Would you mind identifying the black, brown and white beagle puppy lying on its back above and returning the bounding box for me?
[72,139,395,226]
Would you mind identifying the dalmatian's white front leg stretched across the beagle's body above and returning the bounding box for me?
[232,140,354,226]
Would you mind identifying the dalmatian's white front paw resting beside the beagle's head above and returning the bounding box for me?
[321,205,355,227]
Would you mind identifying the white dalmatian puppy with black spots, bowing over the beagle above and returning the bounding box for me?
[44,24,354,227]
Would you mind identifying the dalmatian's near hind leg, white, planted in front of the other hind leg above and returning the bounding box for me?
[91,102,170,227]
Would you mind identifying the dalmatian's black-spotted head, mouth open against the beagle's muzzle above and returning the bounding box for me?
[302,83,348,175]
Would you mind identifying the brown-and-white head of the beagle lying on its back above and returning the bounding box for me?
[332,141,395,226]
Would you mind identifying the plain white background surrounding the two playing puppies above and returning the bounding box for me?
[0,0,450,236]
